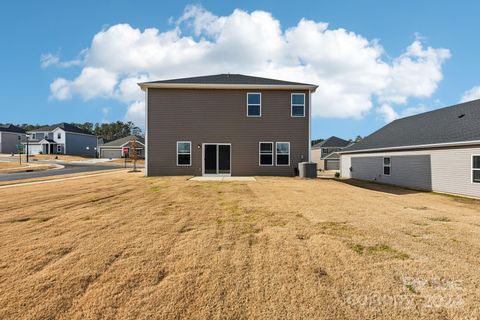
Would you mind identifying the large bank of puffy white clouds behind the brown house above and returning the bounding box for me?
[46,6,450,125]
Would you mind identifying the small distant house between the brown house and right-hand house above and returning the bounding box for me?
[311,136,351,170]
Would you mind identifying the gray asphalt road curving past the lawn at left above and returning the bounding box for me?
[0,163,123,181]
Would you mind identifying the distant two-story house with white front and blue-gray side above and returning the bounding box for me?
[23,123,97,156]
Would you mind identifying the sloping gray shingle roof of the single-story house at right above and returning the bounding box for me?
[342,100,480,152]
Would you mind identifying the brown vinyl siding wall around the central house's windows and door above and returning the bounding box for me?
[147,89,309,176]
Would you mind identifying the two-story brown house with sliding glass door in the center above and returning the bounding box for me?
[139,74,317,176]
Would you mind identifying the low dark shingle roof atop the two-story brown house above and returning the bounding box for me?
[143,73,314,86]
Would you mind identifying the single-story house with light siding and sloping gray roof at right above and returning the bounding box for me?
[340,100,480,197]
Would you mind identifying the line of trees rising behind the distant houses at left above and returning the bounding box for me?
[0,121,143,141]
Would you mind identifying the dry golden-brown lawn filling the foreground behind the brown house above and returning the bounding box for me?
[0,172,480,319]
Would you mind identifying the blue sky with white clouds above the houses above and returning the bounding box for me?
[0,0,480,138]
